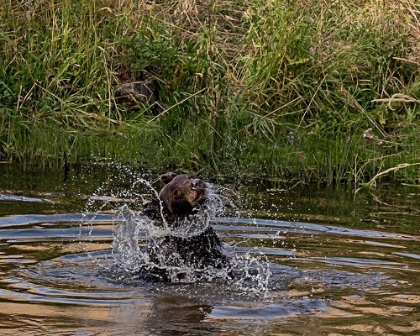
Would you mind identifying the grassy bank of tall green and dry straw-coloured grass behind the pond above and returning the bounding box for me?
[0,0,420,183]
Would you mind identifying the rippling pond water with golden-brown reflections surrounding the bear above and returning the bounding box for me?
[0,164,420,335]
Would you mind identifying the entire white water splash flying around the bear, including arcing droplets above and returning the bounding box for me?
[84,174,270,296]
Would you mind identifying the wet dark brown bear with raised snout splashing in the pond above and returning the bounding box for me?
[143,173,234,281]
